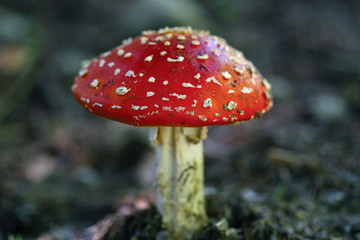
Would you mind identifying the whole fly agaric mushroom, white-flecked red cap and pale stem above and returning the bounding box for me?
[72,27,272,239]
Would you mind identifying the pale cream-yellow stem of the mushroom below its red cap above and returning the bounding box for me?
[154,127,207,239]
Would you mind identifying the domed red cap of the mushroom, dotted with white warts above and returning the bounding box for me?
[72,27,272,127]
